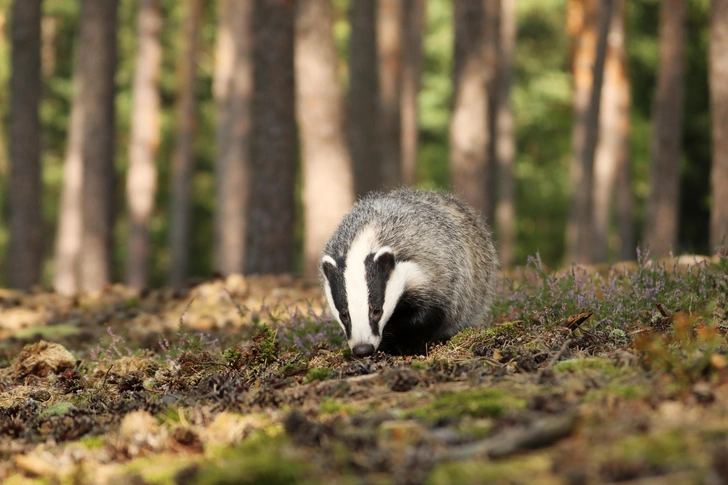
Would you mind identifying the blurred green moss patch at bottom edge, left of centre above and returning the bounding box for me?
[191,436,310,485]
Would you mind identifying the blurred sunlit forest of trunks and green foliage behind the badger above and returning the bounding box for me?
[0,0,728,294]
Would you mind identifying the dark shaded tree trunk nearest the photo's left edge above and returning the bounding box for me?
[8,0,43,290]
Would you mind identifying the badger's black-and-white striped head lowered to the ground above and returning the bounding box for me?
[321,227,425,357]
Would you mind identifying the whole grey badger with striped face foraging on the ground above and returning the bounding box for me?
[320,189,498,357]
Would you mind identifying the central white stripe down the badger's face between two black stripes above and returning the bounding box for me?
[344,227,381,348]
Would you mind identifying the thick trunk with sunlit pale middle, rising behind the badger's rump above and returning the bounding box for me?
[450,0,489,217]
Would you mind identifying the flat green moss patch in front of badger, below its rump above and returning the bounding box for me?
[412,389,526,421]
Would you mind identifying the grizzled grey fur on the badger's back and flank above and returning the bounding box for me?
[322,189,498,350]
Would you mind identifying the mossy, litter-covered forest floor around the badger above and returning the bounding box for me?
[0,254,728,485]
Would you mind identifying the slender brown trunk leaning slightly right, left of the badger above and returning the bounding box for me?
[169,0,202,289]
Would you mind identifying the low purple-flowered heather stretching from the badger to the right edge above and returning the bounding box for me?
[492,249,719,328]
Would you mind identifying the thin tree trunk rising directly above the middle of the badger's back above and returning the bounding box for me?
[400,0,427,185]
